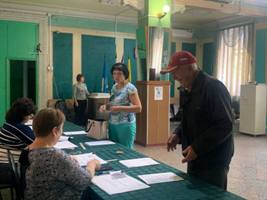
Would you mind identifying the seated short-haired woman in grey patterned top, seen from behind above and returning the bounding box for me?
[20,108,100,200]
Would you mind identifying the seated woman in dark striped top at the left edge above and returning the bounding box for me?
[0,98,35,187]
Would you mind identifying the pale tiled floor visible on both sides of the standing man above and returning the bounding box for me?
[135,122,267,200]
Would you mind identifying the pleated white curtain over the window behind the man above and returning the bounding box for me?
[215,24,253,96]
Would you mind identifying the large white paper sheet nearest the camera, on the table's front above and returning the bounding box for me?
[92,174,150,195]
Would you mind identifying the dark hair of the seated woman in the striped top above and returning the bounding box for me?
[6,98,36,123]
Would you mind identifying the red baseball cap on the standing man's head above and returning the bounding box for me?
[160,51,197,74]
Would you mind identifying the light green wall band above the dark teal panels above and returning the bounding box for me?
[52,15,137,33]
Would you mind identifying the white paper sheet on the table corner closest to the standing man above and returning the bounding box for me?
[138,172,184,184]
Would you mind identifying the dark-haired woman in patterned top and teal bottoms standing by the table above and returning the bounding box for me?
[100,63,142,148]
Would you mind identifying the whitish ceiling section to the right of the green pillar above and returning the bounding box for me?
[172,0,267,29]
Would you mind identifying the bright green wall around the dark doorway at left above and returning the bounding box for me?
[0,20,38,124]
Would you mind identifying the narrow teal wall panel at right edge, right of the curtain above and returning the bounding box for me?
[255,29,267,83]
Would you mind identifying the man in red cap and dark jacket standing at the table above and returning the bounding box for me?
[161,51,234,190]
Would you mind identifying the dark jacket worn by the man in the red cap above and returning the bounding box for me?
[175,71,234,169]
